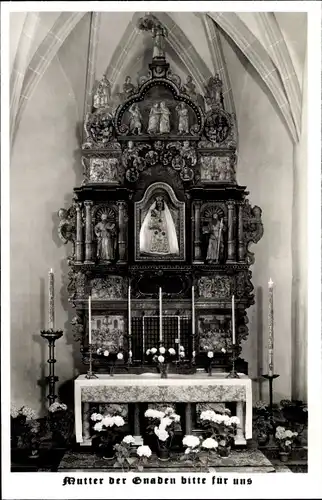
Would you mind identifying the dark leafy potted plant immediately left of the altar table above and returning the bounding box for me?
[48,401,74,448]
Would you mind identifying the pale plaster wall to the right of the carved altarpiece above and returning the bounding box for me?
[223,31,293,401]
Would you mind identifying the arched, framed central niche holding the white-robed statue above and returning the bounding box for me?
[135,182,185,261]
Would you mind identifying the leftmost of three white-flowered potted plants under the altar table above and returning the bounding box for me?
[91,413,125,460]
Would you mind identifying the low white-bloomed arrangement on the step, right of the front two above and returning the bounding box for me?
[180,435,218,471]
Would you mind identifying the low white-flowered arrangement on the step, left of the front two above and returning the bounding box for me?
[114,435,152,472]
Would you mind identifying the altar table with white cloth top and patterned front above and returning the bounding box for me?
[74,373,252,445]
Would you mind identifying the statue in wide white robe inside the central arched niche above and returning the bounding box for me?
[140,196,179,255]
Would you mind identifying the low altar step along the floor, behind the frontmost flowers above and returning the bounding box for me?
[58,449,274,474]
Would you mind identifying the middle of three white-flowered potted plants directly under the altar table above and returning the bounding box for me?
[144,406,181,460]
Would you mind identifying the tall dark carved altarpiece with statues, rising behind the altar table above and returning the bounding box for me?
[59,14,263,373]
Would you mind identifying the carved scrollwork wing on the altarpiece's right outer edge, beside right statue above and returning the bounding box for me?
[243,200,264,265]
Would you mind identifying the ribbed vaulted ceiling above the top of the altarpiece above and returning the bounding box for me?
[10,12,307,146]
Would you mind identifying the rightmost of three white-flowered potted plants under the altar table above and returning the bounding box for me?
[200,410,240,456]
